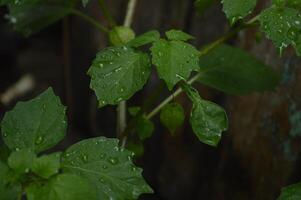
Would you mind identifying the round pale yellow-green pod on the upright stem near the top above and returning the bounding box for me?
[109,26,135,46]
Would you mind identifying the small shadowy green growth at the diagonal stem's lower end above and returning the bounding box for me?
[136,117,155,141]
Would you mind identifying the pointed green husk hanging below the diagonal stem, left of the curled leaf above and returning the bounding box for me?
[160,103,185,134]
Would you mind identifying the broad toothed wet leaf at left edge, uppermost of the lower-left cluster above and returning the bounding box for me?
[1,88,67,153]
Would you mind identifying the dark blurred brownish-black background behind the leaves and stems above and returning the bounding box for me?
[0,0,301,200]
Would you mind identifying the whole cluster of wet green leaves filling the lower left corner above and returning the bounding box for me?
[0,88,152,200]
